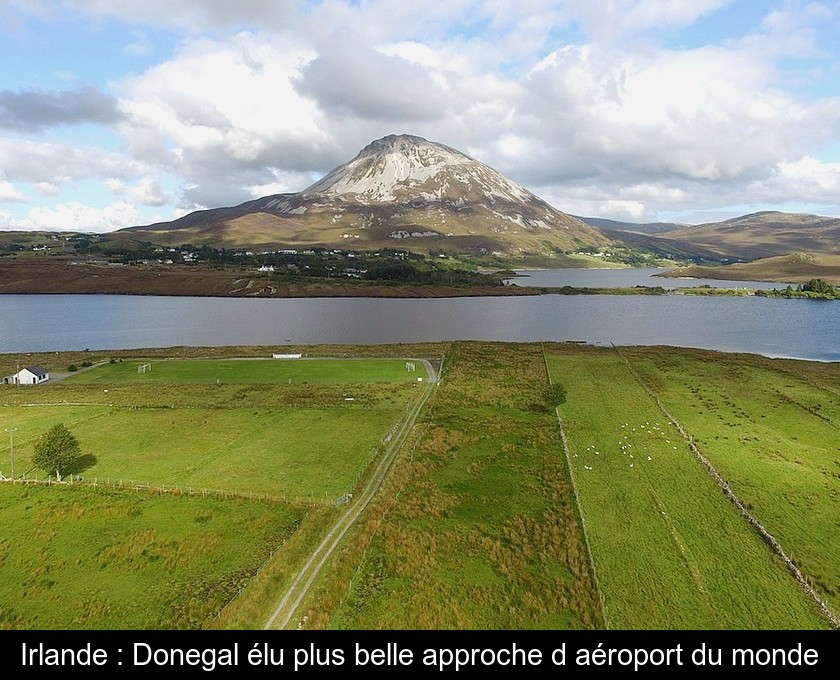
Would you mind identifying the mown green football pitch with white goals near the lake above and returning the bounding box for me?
[66,358,427,385]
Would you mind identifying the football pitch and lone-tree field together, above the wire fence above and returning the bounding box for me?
[0,359,426,499]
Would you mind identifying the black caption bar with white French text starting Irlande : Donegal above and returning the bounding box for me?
[0,631,840,678]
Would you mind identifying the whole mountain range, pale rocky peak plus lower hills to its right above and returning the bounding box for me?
[112,134,840,267]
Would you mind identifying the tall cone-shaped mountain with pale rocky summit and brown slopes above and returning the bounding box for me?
[121,135,609,257]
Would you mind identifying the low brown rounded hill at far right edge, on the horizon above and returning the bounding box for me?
[659,211,840,260]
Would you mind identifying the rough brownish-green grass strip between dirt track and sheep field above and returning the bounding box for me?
[307,343,603,629]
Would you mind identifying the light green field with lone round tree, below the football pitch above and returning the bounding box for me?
[0,405,400,499]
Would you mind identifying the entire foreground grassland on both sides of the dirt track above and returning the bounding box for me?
[0,342,840,630]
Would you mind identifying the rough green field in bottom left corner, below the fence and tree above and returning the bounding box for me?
[0,484,305,630]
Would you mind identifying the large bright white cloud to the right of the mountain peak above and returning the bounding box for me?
[506,37,840,194]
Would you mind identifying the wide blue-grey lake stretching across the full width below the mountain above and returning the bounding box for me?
[0,286,840,361]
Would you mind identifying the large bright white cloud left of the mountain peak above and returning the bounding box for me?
[115,33,331,205]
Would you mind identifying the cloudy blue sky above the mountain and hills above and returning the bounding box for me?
[0,0,840,233]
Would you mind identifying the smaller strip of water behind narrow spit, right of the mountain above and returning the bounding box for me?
[508,269,795,289]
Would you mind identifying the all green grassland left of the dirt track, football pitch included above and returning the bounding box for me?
[0,358,434,629]
